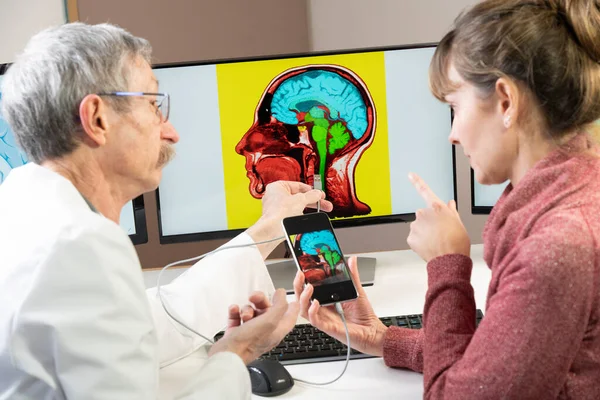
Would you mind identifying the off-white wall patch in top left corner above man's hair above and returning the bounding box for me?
[0,0,66,64]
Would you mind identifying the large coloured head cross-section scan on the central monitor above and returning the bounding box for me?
[235,64,376,218]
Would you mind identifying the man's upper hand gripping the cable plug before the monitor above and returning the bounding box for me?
[246,181,333,258]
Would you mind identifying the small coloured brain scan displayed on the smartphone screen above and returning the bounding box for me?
[290,230,350,286]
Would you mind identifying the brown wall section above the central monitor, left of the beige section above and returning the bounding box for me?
[77,0,308,63]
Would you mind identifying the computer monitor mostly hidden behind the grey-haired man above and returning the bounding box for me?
[0,64,148,244]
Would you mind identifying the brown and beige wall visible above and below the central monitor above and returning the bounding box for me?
[72,0,485,268]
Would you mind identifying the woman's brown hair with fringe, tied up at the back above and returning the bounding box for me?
[429,0,600,138]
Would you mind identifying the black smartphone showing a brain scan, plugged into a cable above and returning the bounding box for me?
[282,212,358,305]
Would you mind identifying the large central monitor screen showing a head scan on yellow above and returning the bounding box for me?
[154,45,456,243]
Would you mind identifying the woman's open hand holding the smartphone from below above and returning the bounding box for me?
[294,257,387,356]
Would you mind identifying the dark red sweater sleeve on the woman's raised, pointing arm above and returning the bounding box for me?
[423,232,594,399]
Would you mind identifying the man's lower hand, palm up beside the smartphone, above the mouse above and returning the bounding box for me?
[208,289,300,364]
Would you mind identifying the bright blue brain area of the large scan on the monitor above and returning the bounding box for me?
[271,70,368,139]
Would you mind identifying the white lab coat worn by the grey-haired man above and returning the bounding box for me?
[0,163,274,400]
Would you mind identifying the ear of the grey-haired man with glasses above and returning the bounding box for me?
[79,94,109,147]
